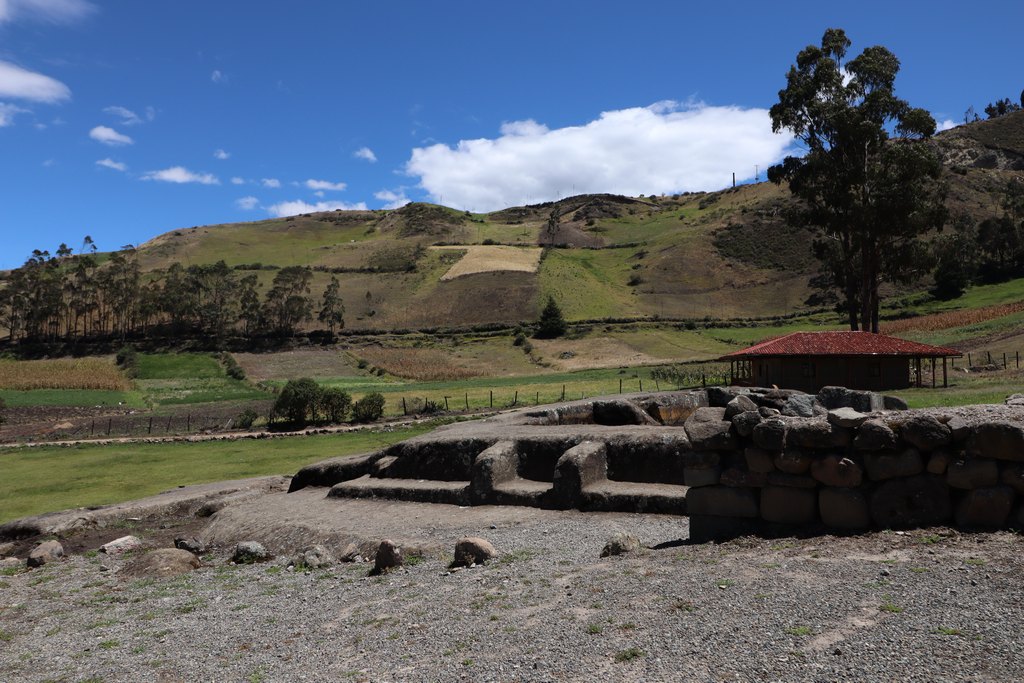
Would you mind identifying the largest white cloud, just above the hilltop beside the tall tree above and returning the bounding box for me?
[406,102,792,211]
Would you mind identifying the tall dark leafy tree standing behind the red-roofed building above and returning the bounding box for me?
[768,29,945,332]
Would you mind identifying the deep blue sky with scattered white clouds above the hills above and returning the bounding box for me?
[0,0,1024,267]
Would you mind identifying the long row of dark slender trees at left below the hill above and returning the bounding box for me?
[0,242,345,342]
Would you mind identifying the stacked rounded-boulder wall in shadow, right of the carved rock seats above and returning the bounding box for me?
[684,389,1024,538]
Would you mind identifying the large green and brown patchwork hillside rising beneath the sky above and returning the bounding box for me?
[6,113,1024,331]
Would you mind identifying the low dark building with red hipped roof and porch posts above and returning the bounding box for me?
[719,332,963,392]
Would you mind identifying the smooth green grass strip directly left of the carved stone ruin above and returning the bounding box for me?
[0,426,431,523]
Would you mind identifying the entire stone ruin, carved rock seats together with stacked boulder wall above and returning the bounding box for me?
[292,387,1024,539]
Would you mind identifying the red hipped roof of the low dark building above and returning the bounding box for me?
[720,332,963,360]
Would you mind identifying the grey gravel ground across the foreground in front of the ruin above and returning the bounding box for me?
[0,492,1024,682]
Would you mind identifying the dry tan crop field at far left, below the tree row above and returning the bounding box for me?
[0,358,131,391]
